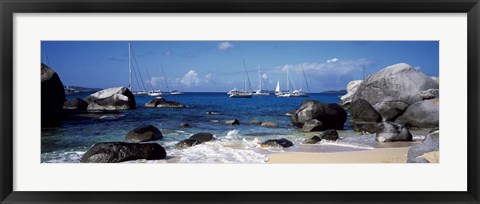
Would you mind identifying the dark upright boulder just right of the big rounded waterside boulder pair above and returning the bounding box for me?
[350,99,382,133]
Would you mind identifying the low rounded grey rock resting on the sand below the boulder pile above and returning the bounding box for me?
[375,121,412,142]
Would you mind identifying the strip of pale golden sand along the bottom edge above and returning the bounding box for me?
[267,147,408,164]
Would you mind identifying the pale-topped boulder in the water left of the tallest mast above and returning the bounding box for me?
[84,86,135,110]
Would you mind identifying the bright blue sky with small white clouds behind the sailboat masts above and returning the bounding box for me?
[41,41,439,92]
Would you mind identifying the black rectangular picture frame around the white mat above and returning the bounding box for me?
[0,0,480,203]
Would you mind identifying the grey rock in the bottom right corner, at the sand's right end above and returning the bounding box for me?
[407,131,440,163]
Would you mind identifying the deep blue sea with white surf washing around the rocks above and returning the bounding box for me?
[41,93,426,163]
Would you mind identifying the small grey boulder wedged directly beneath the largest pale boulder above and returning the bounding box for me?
[373,101,408,121]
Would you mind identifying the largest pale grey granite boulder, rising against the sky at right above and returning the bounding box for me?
[352,63,438,106]
